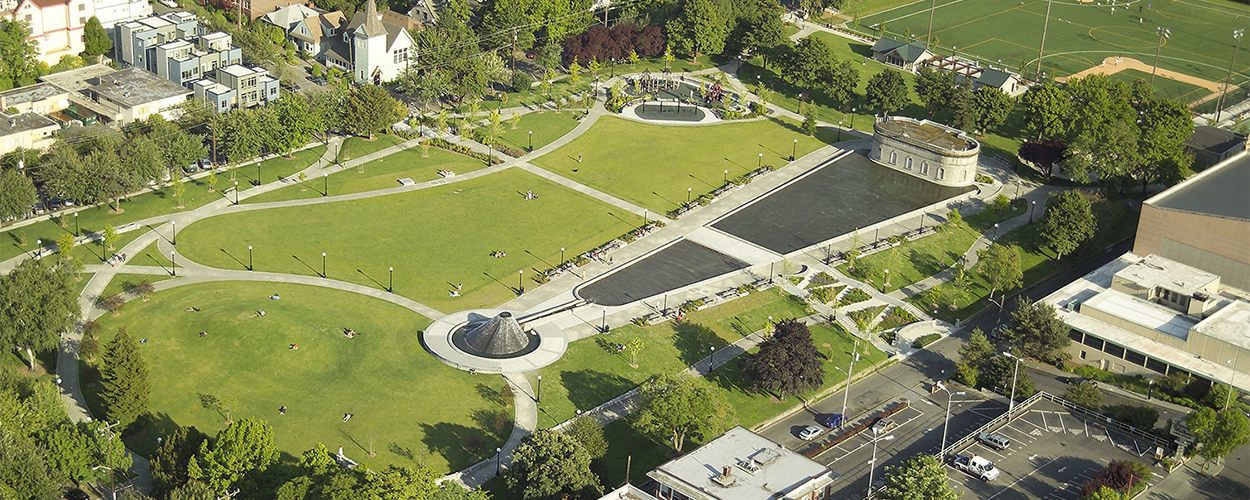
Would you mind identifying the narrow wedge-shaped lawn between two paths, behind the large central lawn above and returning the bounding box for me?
[244,146,486,204]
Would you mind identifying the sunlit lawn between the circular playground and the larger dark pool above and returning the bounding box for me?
[533,116,829,214]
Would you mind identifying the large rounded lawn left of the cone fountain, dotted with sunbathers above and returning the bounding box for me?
[84,283,511,473]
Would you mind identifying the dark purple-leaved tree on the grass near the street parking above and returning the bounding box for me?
[743,319,825,399]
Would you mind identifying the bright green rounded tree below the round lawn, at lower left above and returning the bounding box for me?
[186,419,278,494]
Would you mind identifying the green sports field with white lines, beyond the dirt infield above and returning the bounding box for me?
[859,0,1250,84]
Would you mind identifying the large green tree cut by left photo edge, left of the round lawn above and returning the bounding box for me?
[0,259,81,369]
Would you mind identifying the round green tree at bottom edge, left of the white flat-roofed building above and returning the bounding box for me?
[508,430,600,500]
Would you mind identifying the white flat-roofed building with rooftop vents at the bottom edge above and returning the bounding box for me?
[646,426,838,500]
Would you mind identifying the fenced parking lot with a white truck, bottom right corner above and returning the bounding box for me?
[948,400,1166,500]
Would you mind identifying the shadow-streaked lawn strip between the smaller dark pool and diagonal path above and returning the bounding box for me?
[528,288,819,428]
